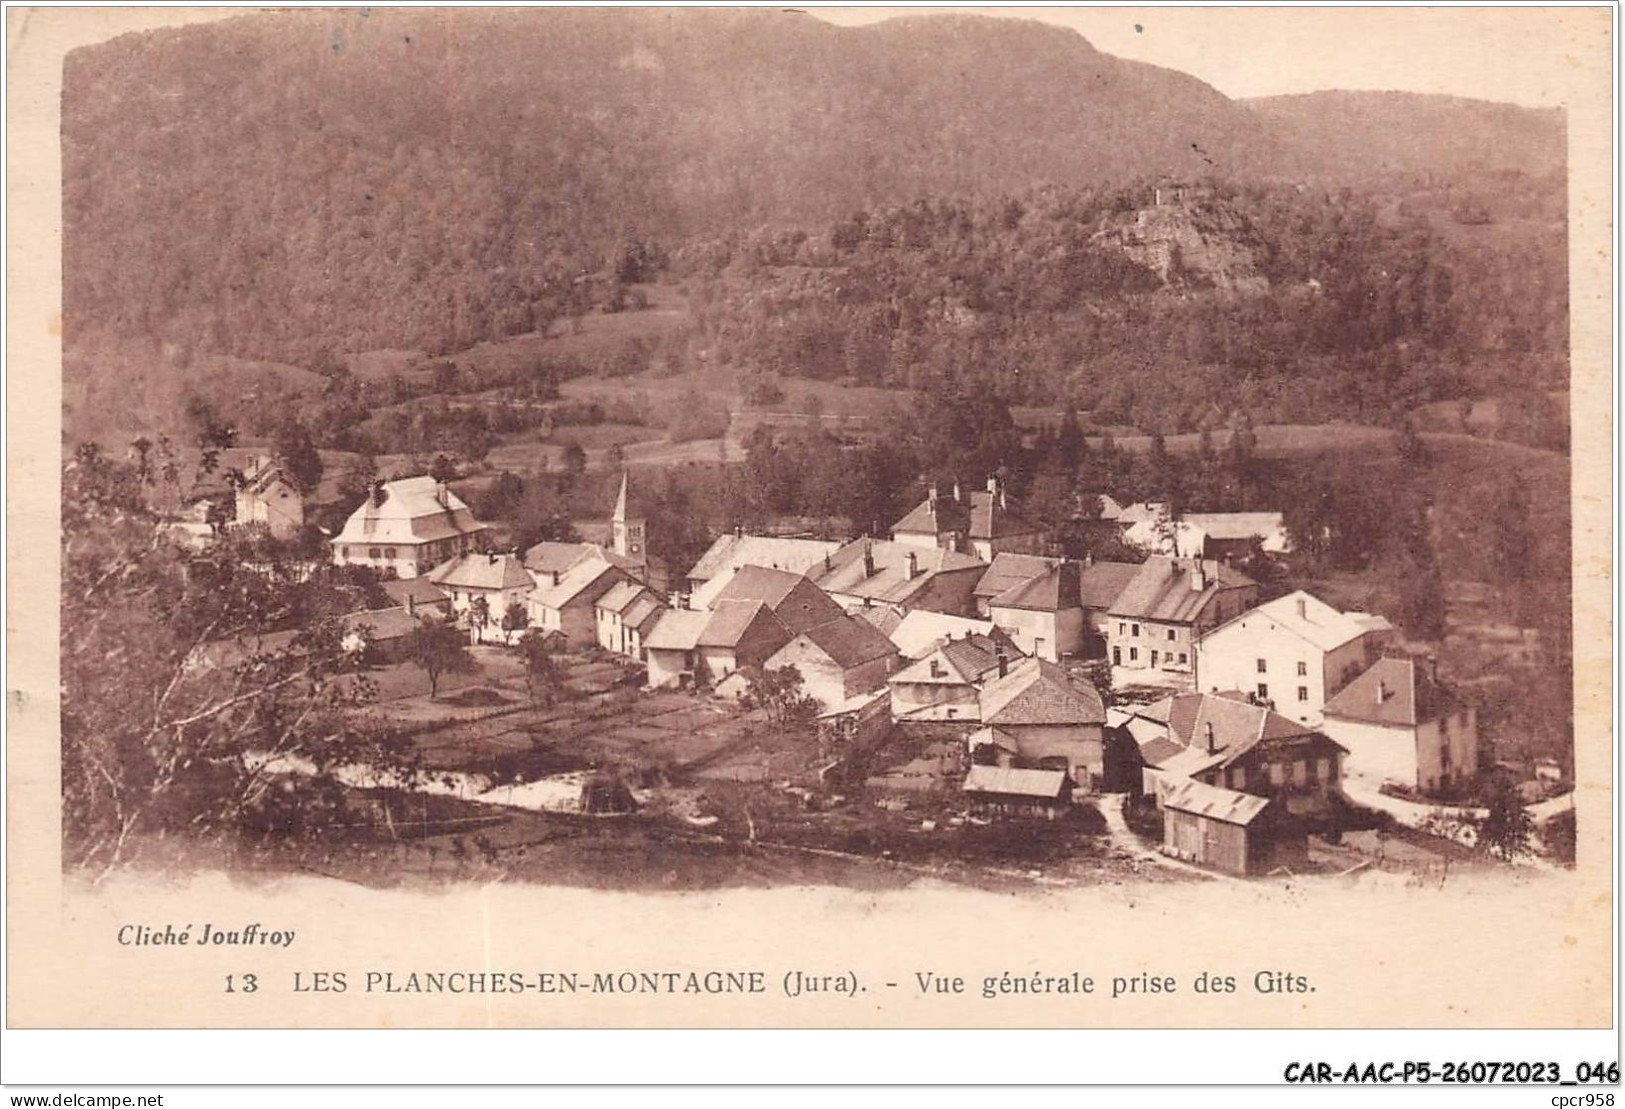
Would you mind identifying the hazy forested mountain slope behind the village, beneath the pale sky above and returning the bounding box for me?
[63,10,1562,426]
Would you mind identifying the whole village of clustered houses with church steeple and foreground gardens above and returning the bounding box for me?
[146,455,1570,881]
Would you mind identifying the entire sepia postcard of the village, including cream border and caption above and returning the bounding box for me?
[8,7,1617,1081]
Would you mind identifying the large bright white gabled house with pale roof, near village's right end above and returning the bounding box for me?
[1196,589,1389,724]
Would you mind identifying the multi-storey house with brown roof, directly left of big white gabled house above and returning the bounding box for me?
[1107,555,1258,688]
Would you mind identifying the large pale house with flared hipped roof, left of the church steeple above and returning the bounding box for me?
[332,475,489,577]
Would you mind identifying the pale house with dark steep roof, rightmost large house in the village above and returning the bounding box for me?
[1324,659,1479,794]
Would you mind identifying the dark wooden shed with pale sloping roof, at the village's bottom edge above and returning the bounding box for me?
[1162,781,1307,875]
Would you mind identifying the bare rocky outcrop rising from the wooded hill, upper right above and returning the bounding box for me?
[1095,184,1269,294]
